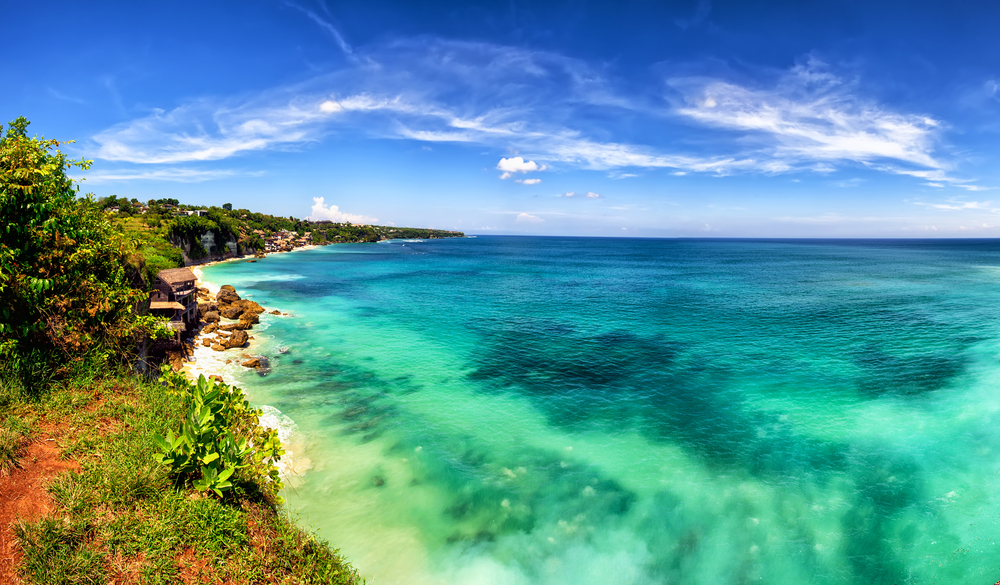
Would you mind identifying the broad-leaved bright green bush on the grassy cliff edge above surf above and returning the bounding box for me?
[154,366,284,502]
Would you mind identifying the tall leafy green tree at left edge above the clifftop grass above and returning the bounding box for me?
[0,117,157,381]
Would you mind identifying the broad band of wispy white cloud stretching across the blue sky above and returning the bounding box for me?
[94,38,981,190]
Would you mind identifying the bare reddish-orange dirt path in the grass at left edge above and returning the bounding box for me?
[0,435,80,583]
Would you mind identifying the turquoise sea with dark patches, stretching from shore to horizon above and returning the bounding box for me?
[199,237,1000,585]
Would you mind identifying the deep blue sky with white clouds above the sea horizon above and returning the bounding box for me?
[0,0,1000,238]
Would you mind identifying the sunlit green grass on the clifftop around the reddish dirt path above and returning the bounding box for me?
[0,374,360,584]
